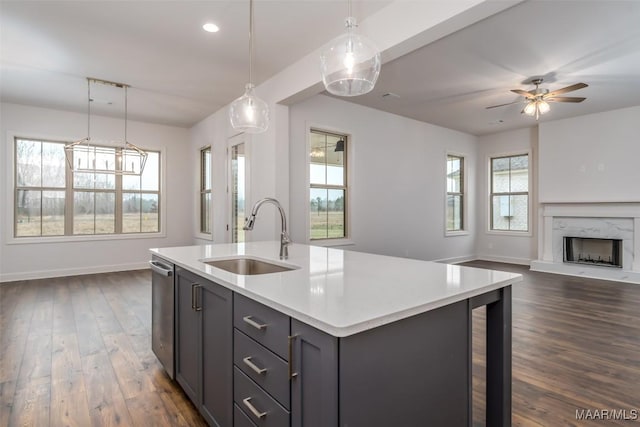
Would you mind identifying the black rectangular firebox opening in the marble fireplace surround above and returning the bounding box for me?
[563,236,622,268]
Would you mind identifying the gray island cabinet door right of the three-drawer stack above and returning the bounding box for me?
[290,319,340,427]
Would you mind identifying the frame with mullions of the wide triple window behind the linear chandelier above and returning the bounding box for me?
[9,132,166,244]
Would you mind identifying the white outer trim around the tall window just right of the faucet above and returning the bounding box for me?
[304,123,355,247]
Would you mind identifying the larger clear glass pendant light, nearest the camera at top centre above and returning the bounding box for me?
[320,0,381,96]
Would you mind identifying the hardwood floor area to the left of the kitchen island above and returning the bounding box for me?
[0,270,206,427]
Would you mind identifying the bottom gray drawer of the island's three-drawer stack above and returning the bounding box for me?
[233,367,289,427]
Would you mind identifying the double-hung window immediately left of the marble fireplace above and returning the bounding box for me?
[490,154,529,231]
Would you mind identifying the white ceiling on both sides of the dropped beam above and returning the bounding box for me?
[0,0,640,135]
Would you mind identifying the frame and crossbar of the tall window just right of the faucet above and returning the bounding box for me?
[305,124,354,247]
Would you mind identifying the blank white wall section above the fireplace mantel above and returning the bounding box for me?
[539,106,640,203]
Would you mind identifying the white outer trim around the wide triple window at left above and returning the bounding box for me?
[4,131,167,245]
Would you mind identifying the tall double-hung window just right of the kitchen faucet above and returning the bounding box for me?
[309,129,348,240]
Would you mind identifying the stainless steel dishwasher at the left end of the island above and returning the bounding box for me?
[149,255,175,378]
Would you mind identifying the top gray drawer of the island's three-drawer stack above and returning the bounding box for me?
[233,294,289,360]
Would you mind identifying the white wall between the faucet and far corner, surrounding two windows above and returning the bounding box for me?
[289,95,476,260]
